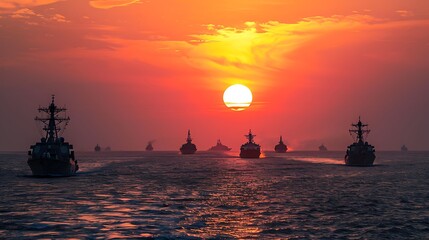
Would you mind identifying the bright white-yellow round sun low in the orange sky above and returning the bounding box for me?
[223,84,252,111]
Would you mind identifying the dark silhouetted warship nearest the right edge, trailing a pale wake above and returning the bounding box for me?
[345,117,375,166]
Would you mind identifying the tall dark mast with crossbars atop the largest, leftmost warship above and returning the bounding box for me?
[34,95,70,143]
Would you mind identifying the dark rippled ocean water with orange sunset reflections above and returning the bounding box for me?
[0,152,429,239]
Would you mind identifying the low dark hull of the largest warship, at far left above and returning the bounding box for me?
[27,158,78,177]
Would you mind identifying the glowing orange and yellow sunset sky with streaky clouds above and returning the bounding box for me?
[0,0,429,151]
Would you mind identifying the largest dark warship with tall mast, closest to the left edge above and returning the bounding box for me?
[27,95,79,177]
